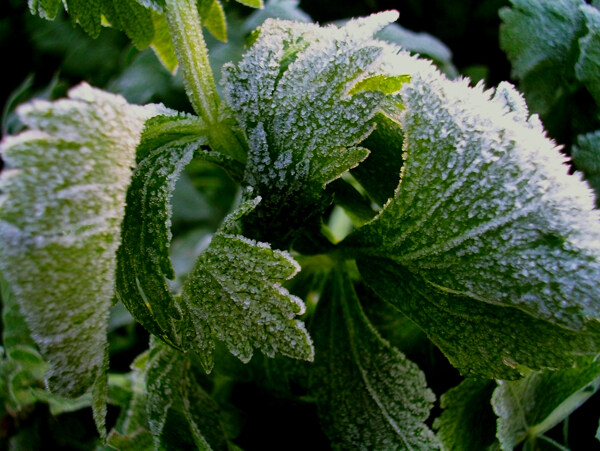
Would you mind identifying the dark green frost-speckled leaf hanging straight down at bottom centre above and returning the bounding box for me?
[311,270,440,449]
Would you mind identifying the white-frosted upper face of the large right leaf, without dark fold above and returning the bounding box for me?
[348,54,600,330]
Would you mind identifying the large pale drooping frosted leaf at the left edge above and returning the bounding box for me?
[0,84,156,396]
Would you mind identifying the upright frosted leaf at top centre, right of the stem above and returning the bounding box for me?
[224,12,410,245]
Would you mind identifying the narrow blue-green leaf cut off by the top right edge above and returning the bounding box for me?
[575,4,600,106]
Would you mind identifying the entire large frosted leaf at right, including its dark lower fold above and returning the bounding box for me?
[347,55,600,378]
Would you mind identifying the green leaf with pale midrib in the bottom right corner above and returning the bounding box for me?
[492,358,600,450]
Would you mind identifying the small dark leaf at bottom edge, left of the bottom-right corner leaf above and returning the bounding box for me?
[433,379,496,451]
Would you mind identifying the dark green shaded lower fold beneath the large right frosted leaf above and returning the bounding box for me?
[358,258,600,379]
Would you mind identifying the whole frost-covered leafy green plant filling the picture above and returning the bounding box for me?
[0,0,600,449]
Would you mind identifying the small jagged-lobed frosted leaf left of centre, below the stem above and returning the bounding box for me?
[181,201,313,371]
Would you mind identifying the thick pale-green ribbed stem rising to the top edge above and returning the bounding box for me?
[165,0,220,125]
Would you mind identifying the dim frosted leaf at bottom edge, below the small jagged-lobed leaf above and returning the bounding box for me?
[146,342,228,450]
